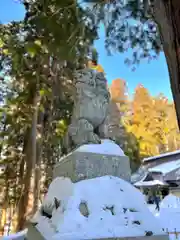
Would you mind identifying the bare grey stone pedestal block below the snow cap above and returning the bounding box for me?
[53,151,131,182]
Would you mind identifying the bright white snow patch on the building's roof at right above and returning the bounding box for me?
[148,160,180,174]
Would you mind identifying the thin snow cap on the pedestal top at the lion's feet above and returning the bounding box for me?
[76,139,125,156]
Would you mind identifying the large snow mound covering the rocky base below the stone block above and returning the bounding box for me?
[36,176,163,240]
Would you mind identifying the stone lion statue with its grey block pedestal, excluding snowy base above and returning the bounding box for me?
[53,69,130,182]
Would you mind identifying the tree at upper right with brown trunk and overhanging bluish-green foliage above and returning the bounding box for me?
[85,0,180,130]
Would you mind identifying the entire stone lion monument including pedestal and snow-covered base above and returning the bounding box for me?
[27,69,168,240]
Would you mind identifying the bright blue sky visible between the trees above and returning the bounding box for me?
[0,0,172,99]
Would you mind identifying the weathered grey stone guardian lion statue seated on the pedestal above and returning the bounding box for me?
[66,69,110,151]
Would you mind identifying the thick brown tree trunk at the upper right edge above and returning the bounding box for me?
[154,0,180,128]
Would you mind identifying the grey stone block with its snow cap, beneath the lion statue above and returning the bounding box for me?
[53,140,131,182]
